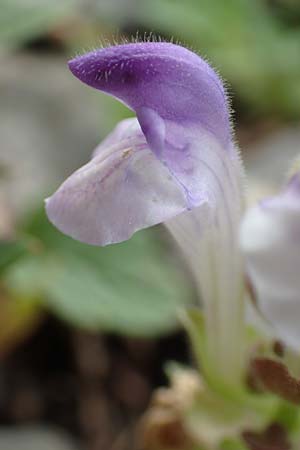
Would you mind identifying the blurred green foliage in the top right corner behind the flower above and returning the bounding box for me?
[138,0,300,118]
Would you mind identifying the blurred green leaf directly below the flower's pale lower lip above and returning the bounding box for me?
[5,212,191,336]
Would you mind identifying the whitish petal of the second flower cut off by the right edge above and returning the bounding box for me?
[241,174,300,351]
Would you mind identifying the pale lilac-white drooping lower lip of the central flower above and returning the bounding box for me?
[46,119,186,245]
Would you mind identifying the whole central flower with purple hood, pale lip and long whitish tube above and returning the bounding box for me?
[46,42,244,383]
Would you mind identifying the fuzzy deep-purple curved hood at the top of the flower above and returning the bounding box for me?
[69,42,230,141]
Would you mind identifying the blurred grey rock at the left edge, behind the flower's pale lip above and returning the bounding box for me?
[0,54,125,216]
